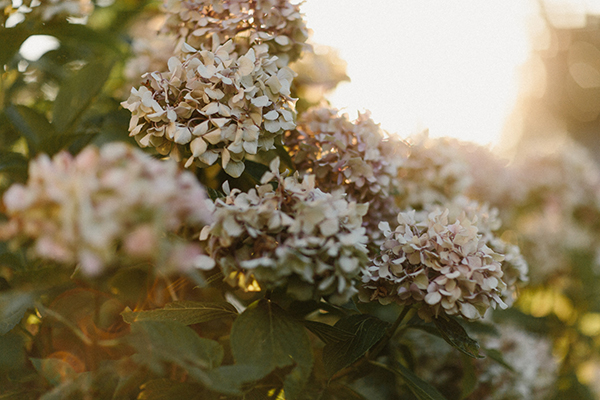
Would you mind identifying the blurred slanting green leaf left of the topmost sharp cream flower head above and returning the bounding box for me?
[52,54,115,135]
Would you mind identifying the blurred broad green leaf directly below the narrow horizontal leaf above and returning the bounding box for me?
[129,321,224,382]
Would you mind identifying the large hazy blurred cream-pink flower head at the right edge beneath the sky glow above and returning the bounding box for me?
[503,143,600,284]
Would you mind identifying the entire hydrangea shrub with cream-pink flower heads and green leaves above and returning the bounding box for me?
[0,0,600,400]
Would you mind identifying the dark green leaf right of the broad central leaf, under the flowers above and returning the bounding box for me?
[323,314,389,377]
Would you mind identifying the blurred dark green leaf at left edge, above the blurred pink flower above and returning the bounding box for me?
[4,104,55,154]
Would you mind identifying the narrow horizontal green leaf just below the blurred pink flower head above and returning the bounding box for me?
[121,301,237,325]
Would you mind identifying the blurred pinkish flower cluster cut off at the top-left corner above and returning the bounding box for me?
[0,0,94,25]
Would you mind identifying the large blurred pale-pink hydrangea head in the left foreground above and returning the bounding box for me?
[0,143,214,276]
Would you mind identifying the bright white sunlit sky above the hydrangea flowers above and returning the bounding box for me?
[302,0,536,144]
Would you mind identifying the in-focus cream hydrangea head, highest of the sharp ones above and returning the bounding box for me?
[122,41,295,177]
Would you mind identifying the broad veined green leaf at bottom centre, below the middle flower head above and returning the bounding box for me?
[231,299,313,399]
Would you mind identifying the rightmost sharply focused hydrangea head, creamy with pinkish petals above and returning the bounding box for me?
[360,208,516,320]
